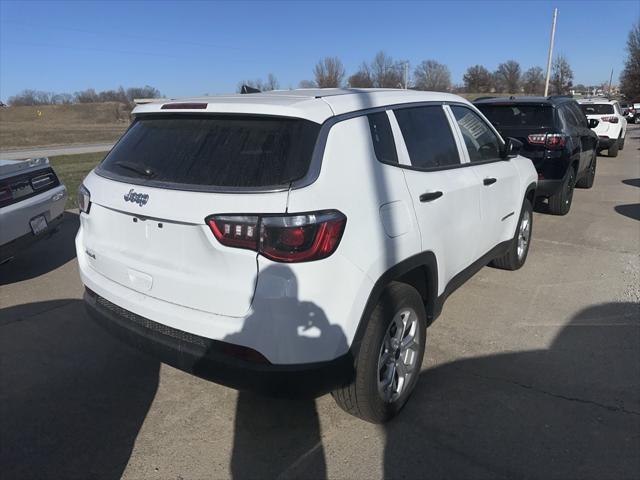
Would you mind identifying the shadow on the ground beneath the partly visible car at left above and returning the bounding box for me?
[0,211,80,286]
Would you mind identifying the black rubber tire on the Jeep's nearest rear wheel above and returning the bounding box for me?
[332,282,427,423]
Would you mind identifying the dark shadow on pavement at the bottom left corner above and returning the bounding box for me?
[0,299,159,480]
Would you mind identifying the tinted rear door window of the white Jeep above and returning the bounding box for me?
[394,106,460,168]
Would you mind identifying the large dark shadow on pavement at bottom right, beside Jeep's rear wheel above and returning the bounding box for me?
[384,303,640,479]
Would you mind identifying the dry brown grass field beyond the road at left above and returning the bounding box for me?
[0,102,131,150]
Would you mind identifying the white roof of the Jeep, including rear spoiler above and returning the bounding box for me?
[132,88,470,123]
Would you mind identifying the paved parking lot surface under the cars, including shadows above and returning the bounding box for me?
[0,126,640,480]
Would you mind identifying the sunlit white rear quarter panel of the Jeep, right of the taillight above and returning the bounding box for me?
[284,117,421,343]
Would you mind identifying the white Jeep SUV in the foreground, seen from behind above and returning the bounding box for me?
[76,89,537,422]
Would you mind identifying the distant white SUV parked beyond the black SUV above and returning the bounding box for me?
[578,99,627,157]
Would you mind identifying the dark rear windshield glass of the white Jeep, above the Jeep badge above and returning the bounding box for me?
[98,115,320,187]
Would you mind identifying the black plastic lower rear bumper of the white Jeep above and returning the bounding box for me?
[84,289,353,396]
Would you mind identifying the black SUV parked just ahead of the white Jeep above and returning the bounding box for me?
[475,96,598,215]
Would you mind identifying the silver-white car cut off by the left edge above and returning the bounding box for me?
[0,158,67,263]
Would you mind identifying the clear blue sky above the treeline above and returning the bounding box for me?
[0,0,640,100]
